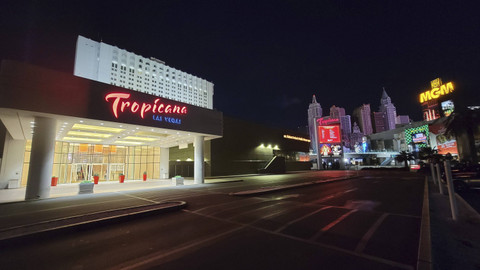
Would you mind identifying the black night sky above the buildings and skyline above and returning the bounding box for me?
[0,0,480,129]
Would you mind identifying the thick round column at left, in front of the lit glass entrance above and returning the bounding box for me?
[25,117,57,200]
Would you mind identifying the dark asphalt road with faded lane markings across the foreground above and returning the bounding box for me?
[0,171,424,269]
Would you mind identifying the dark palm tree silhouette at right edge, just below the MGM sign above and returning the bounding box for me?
[445,107,480,164]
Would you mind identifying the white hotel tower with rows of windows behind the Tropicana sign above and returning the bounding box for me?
[74,36,213,109]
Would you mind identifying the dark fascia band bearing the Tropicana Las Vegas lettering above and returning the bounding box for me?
[0,61,223,136]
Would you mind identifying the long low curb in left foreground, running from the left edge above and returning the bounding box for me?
[0,201,187,245]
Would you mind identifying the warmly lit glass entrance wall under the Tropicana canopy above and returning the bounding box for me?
[22,141,160,186]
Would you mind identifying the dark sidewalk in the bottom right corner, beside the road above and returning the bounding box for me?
[428,178,480,270]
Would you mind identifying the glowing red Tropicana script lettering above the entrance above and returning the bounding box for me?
[105,93,187,119]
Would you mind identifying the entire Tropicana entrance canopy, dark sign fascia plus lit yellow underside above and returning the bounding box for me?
[0,61,223,148]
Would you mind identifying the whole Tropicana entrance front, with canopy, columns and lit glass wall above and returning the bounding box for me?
[0,61,223,200]
